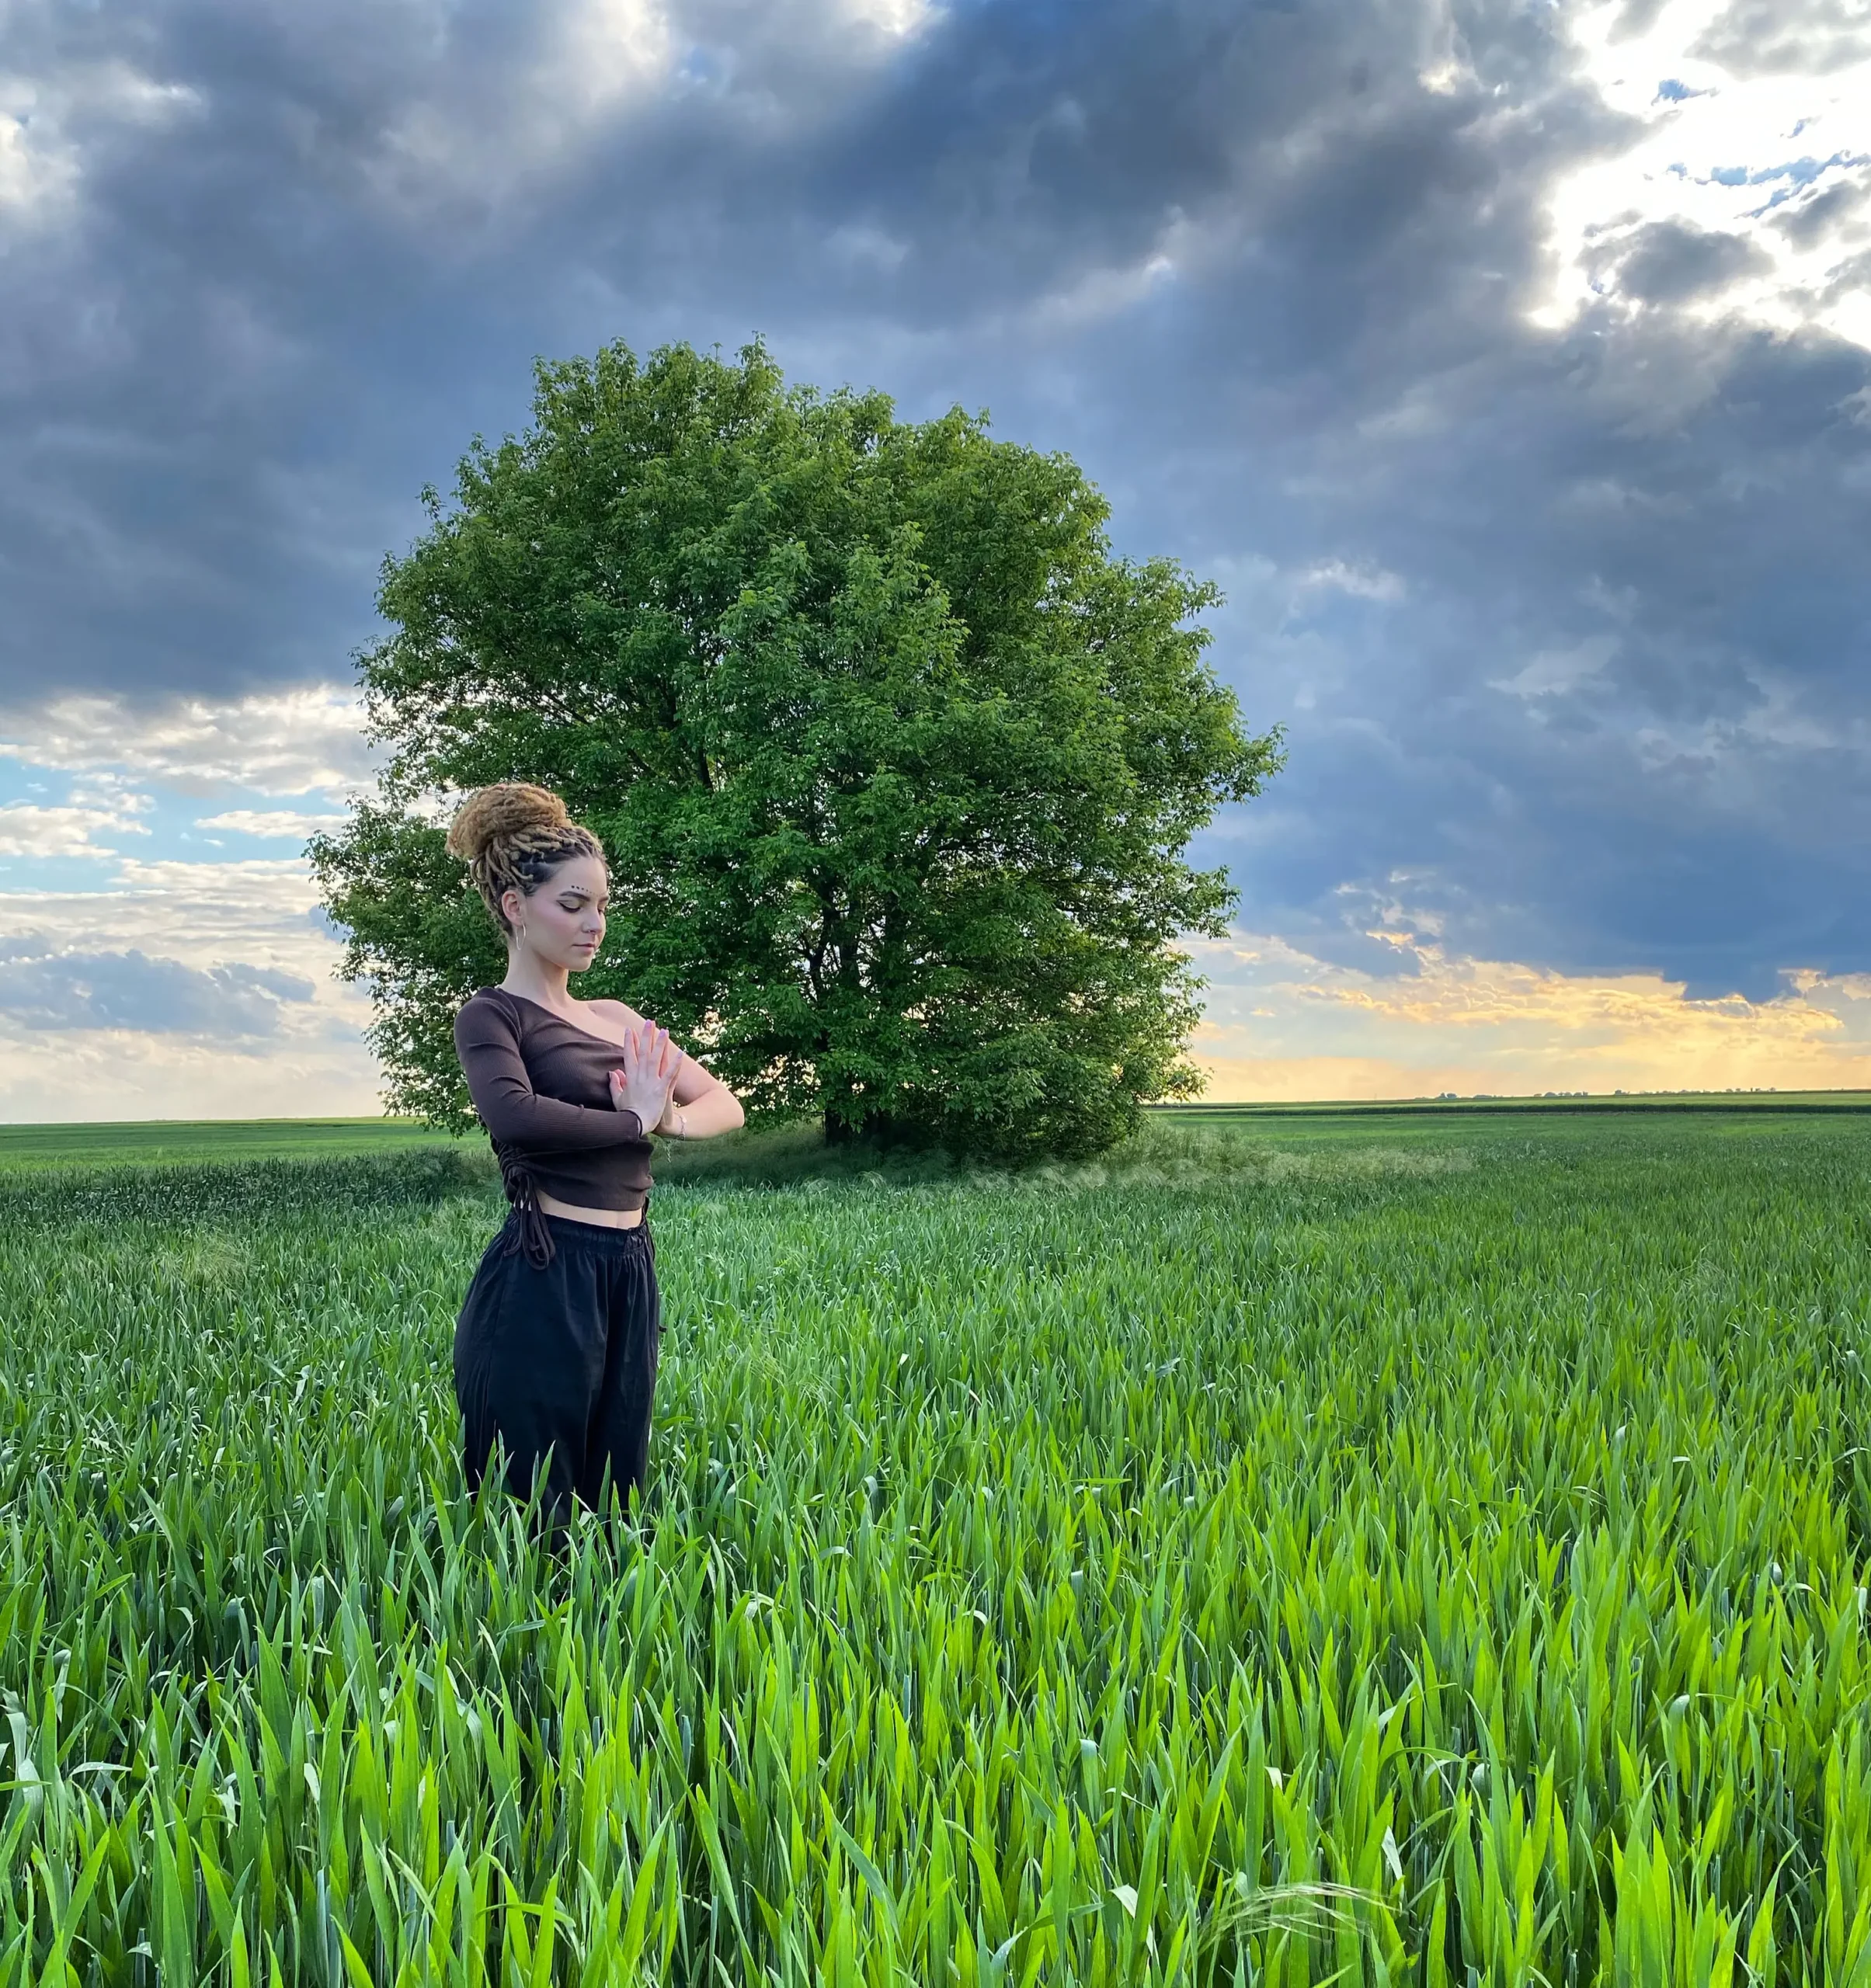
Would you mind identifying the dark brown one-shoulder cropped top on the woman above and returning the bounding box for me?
[455,988,652,1264]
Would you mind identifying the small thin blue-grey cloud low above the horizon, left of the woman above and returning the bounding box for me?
[0,937,312,1037]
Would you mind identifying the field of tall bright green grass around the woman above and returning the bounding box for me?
[0,1100,1871,1988]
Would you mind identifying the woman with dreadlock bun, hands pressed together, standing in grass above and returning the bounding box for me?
[447,781,742,1529]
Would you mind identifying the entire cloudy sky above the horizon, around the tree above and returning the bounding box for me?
[0,0,1871,1121]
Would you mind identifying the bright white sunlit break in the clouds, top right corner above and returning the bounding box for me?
[1535,0,1871,346]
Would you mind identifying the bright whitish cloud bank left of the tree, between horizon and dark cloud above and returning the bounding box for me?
[0,684,380,1121]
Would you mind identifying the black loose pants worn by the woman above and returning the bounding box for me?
[455,1211,662,1529]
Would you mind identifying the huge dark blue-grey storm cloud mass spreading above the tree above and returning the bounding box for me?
[0,0,1871,992]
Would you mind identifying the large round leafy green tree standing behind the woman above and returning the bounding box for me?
[312,346,1278,1159]
